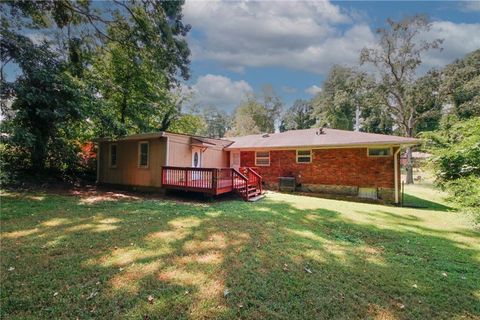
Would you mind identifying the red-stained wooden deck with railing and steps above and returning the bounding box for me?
[162,166,262,200]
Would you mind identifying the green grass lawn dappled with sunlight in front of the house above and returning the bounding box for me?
[0,185,480,319]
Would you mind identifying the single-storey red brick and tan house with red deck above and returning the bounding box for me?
[97,129,419,203]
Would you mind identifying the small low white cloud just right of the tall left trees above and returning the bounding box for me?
[185,74,253,111]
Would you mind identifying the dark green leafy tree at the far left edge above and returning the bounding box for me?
[1,27,88,171]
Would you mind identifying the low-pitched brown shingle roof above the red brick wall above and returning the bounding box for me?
[226,128,420,150]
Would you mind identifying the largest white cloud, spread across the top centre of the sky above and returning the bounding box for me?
[184,1,374,73]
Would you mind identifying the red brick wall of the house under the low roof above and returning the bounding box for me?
[240,148,394,188]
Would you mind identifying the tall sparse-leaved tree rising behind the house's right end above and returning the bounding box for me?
[360,15,442,183]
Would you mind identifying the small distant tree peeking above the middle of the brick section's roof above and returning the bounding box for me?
[280,99,316,132]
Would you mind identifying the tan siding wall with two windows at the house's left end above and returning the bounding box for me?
[100,138,166,187]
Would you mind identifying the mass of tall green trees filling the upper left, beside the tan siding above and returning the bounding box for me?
[0,0,191,180]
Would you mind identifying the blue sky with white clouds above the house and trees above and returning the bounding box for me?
[184,0,480,112]
